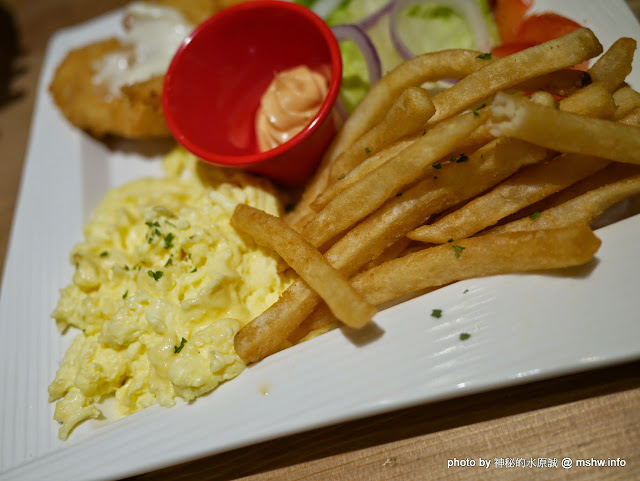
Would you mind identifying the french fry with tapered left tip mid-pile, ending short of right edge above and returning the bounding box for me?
[407,154,610,244]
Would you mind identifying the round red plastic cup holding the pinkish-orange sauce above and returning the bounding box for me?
[162,0,342,186]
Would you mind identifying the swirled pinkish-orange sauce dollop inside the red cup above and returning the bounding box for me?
[256,65,328,152]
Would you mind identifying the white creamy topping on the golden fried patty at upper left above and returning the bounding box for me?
[93,2,194,96]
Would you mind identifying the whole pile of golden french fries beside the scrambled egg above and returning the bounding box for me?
[232,28,640,363]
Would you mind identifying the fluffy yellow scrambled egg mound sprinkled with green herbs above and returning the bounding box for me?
[49,149,291,439]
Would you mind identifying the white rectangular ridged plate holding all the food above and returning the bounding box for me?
[0,0,640,481]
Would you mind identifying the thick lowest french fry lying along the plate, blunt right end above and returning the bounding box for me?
[351,224,600,304]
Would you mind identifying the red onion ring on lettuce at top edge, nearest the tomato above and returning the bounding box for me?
[389,0,491,60]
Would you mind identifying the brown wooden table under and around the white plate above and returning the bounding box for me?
[0,0,640,481]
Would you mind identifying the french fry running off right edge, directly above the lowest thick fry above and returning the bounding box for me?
[485,175,640,235]
